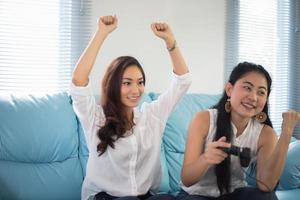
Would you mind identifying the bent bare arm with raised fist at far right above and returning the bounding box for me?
[257,111,300,191]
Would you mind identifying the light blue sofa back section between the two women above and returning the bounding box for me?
[151,94,220,193]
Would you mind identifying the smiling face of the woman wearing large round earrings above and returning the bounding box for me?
[226,72,268,118]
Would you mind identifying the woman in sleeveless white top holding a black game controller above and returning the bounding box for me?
[177,62,300,200]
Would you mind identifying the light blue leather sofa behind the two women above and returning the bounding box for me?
[0,93,300,200]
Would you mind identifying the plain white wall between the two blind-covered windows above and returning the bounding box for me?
[91,0,225,94]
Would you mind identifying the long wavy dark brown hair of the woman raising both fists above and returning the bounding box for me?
[97,56,146,156]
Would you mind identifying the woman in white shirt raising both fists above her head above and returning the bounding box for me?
[70,16,191,200]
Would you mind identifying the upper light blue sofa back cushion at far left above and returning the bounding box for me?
[0,93,78,162]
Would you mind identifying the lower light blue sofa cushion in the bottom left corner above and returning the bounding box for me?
[0,158,83,200]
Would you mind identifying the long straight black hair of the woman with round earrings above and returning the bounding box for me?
[213,62,272,195]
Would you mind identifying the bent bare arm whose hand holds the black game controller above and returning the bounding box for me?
[181,111,230,187]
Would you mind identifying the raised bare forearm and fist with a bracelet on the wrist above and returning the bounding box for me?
[151,23,189,75]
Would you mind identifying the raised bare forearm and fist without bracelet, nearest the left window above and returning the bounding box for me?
[72,16,118,86]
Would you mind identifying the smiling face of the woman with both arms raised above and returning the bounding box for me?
[121,65,145,110]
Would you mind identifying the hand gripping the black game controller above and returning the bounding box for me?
[203,136,231,165]
